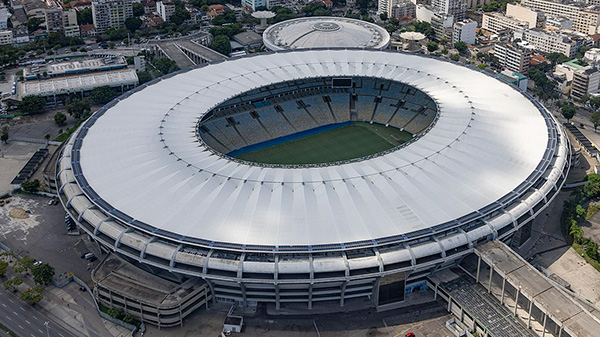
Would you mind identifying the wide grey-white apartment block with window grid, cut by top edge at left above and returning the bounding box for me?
[92,0,133,33]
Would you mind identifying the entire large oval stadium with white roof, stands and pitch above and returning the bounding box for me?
[57,49,570,311]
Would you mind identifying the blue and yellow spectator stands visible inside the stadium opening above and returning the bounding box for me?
[198,78,436,153]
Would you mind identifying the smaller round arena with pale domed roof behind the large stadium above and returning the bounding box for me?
[263,16,390,50]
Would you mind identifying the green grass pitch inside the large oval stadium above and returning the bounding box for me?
[236,122,412,165]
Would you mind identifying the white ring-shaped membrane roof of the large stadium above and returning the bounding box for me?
[77,49,551,246]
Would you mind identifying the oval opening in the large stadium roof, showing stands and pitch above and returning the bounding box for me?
[196,77,438,167]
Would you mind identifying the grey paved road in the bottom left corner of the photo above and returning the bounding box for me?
[0,289,76,337]
